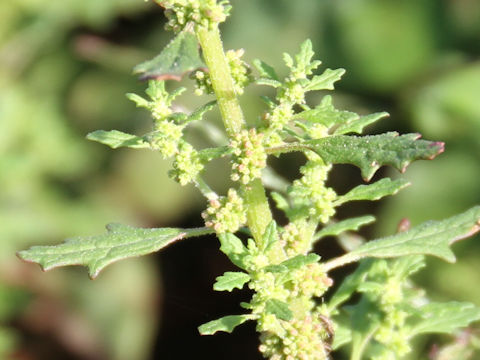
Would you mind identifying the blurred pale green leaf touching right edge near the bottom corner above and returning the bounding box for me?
[411,301,480,336]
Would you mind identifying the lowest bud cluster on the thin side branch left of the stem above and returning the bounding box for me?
[169,141,203,186]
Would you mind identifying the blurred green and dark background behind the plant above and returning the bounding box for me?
[0,0,480,360]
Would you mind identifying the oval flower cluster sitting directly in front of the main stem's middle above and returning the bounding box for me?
[229,129,267,184]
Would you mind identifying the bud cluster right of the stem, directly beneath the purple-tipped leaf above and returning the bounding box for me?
[289,156,337,224]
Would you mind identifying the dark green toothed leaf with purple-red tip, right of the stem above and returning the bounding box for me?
[305,132,444,181]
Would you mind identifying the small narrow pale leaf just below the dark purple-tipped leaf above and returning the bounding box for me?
[334,178,410,206]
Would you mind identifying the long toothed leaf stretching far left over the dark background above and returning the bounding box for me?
[17,224,212,279]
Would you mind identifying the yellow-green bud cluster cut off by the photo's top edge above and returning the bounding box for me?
[156,0,231,32]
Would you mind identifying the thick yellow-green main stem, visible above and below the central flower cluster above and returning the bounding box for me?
[197,26,272,243]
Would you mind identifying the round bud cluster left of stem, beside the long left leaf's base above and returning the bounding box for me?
[202,188,247,234]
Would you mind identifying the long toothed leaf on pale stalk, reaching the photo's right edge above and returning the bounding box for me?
[325,206,480,271]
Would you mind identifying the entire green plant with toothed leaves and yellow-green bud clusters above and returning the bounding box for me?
[19,0,480,360]
